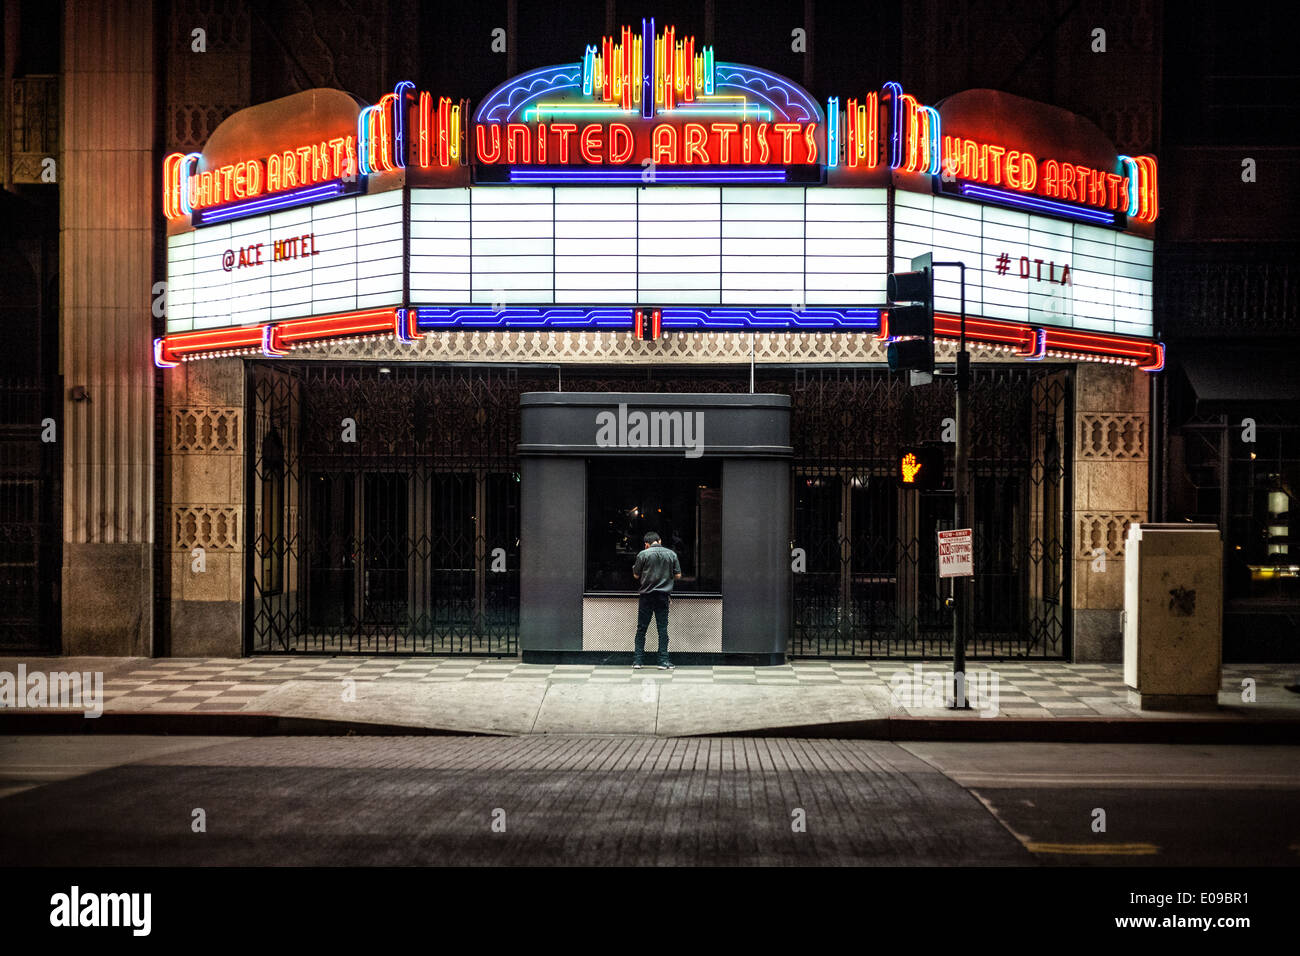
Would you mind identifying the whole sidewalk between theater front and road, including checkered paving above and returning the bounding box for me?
[0,656,1300,743]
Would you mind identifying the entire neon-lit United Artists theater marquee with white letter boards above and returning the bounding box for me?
[155,21,1164,371]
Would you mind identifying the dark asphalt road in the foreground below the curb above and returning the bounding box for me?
[0,735,1300,866]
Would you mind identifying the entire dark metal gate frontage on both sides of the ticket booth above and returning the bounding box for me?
[246,362,1074,657]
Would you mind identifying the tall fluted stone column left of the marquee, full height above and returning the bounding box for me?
[59,0,155,656]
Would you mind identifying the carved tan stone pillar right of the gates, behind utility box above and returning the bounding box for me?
[1074,362,1151,662]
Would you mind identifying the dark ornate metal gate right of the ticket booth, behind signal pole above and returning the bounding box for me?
[787,368,1073,658]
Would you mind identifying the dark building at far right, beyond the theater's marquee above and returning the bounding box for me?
[1152,0,1300,661]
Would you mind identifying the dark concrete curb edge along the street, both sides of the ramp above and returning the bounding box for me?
[0,710,1300,744]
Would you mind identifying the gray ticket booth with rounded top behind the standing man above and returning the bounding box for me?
[519,392,792,665]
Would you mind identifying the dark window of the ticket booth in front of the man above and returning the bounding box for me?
[586,458,722,593]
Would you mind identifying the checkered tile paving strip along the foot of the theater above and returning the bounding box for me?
[73,657,1300,717]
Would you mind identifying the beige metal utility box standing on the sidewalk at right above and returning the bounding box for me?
[1125,524,1223,710]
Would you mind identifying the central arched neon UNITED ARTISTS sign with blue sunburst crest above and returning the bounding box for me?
[473,20,826,182]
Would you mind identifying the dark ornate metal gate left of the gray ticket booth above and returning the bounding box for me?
[247,363,538,654]
